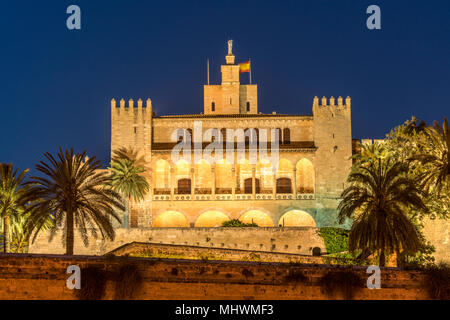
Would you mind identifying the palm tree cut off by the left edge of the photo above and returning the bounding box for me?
[0,163,30,253]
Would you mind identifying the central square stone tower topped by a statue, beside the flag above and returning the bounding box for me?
[204,40,258,115]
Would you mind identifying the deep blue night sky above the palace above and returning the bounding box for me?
[0,0,450,169]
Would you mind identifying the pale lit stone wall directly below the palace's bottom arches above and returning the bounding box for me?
[29,227,326,255]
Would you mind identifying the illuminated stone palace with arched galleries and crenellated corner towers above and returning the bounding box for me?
[111,43,352,228]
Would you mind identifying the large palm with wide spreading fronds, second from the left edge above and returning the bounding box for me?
[28,148,124,255]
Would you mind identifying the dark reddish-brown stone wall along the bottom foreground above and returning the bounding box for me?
[0,254,429,300]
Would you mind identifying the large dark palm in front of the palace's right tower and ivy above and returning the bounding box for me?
[338,157,427,266]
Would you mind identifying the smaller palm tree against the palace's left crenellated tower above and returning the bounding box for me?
[109,158,149,227]
